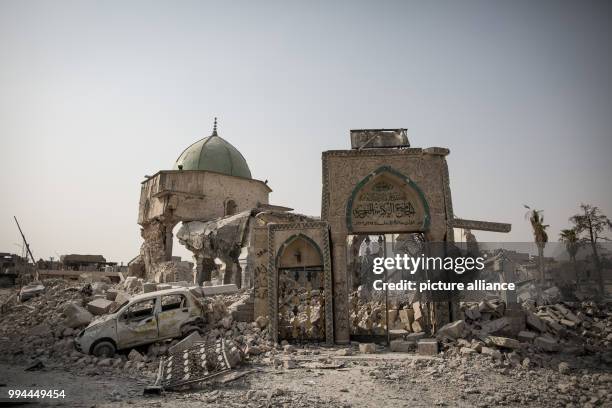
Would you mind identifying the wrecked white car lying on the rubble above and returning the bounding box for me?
[75,288,204,357]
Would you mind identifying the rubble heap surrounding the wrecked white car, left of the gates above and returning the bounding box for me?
[0,277,272,380]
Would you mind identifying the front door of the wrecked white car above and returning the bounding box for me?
[117,298,159,349]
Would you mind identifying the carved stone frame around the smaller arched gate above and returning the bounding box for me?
[268,221,334,344]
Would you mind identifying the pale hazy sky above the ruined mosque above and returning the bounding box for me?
[0,0,612,262]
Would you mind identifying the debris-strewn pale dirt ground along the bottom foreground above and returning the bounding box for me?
[0,349,612,408]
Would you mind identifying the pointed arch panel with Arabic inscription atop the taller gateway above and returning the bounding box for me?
[346,166,431,234]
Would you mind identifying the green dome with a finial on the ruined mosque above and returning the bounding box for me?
[174,130,251,179]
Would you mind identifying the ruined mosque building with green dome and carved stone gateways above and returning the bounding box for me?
[138,121,510,344]
